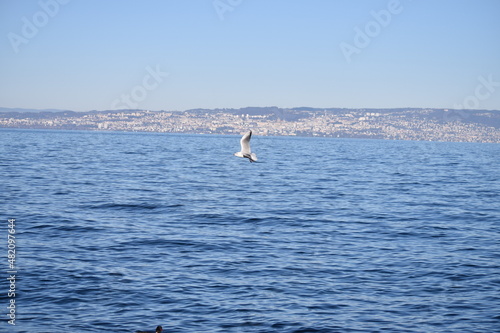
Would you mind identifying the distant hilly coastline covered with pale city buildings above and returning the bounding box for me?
[0,107,500,143]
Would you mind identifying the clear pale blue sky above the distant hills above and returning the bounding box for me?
[0,0,500,111]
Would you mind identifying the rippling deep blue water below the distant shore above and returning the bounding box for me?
[0,129,500,333]
